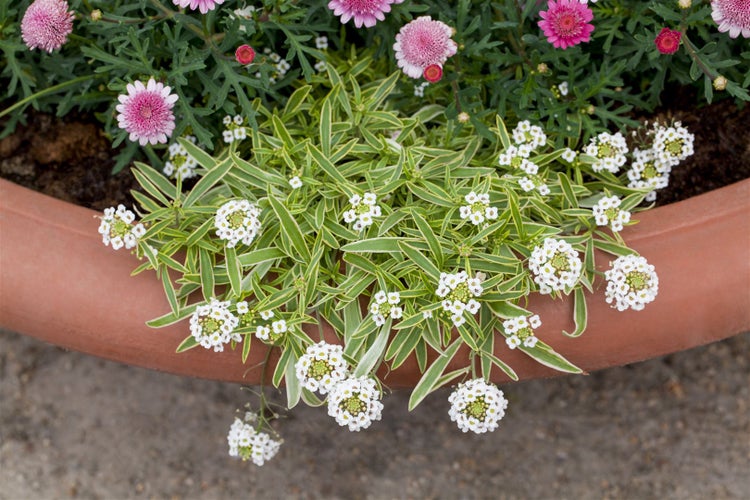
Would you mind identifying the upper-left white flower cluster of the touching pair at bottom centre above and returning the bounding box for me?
[294,341,348,394]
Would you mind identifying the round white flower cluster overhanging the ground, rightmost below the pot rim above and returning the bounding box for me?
[448,378,508,434]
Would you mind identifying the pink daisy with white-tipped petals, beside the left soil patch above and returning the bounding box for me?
[115,78,177,146]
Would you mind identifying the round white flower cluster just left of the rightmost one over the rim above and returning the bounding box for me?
[529,238,583,295]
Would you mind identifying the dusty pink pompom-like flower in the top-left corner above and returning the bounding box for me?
[21,0,73,52]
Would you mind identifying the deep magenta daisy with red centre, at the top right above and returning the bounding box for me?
[539,0,594,49]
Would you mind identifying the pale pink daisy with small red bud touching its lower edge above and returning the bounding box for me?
[393,16,458,78]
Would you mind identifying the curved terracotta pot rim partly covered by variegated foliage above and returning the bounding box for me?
[0,180,750,387]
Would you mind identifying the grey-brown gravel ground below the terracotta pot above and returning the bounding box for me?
[0,331,750,499]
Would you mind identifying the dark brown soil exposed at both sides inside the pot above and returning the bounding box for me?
[0,97,750,210]
